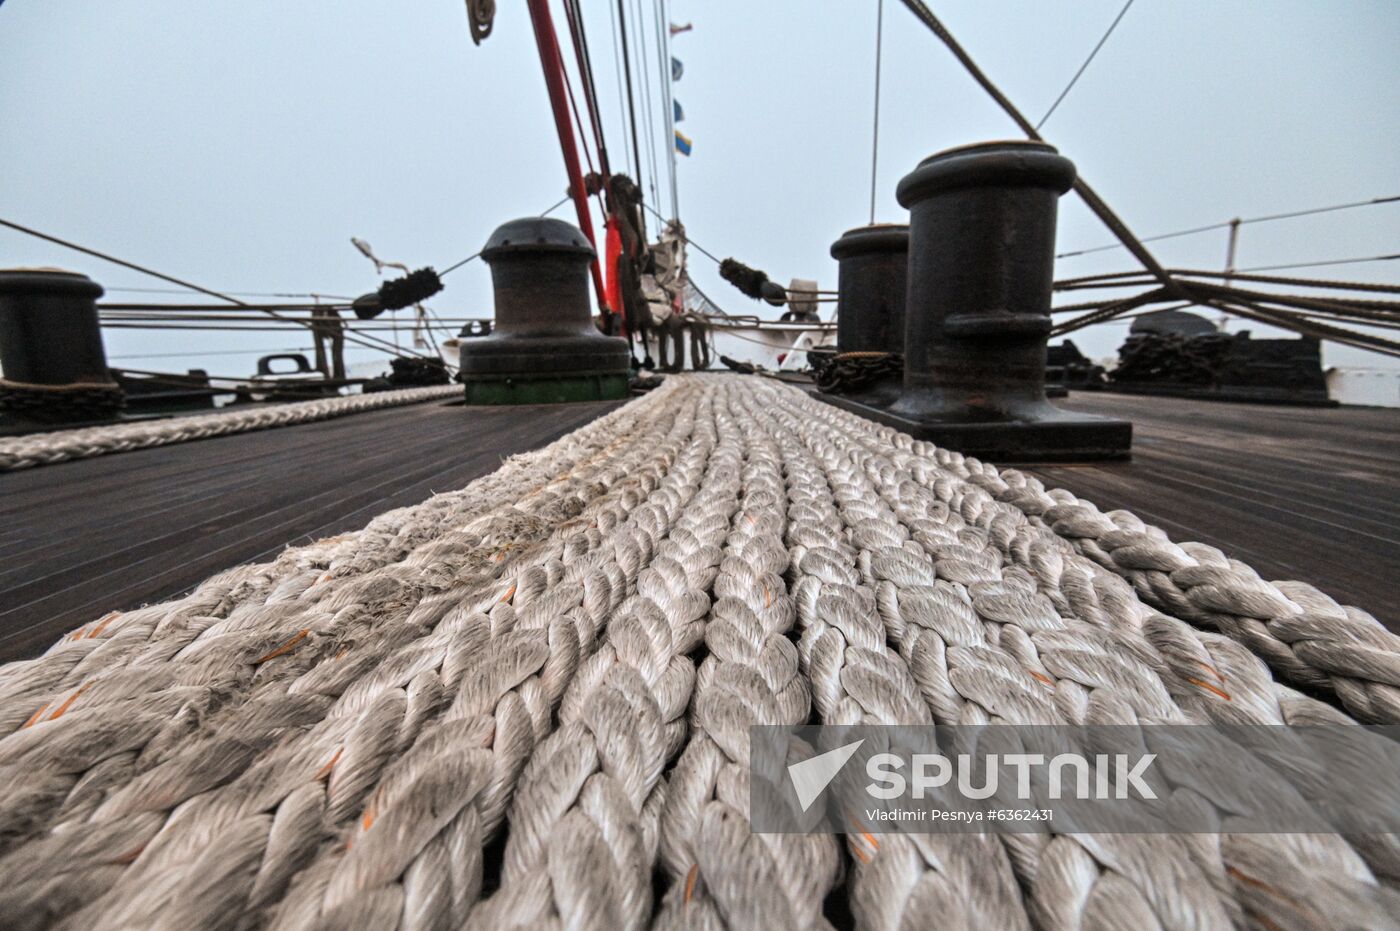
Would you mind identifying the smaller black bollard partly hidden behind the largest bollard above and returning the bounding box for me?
[818,223,909,413]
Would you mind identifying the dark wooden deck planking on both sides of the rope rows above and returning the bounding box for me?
[0,393,1400,659]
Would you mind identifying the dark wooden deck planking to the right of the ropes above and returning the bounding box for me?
[1026,392,1400,621]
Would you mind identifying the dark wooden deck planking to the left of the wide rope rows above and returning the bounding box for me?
[0,402,620,661]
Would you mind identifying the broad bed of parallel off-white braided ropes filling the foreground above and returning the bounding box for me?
[0,375,1400,928]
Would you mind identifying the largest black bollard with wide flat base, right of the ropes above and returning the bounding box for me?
[869,141,1133,462]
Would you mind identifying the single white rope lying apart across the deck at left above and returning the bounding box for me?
[0,385,462,472]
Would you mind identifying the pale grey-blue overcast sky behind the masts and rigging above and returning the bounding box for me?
[0,0,1400,374]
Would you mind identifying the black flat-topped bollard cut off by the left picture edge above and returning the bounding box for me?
[0,269,123,431]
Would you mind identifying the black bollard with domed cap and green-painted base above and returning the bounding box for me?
[461,217,631,405]
